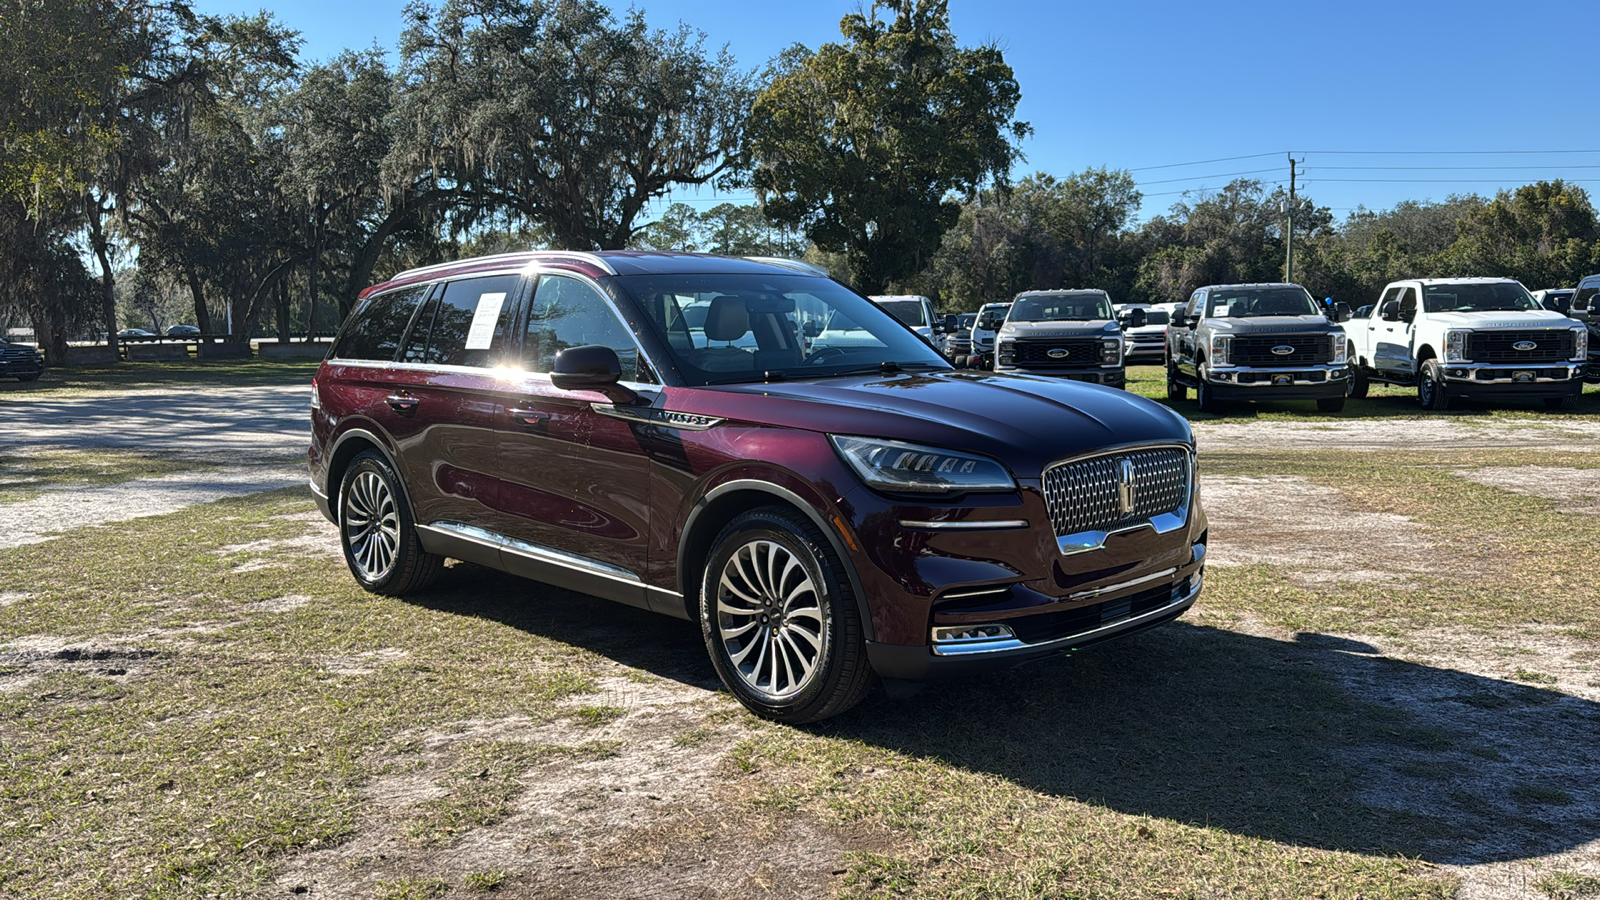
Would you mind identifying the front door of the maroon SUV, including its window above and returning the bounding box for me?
[498,274,656,605]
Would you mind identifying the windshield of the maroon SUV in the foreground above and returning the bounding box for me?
[614,272,950,384]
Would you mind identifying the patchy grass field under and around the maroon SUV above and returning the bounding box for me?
[0,360,1600,900]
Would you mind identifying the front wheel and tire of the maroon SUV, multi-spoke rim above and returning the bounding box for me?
[699,508,872,724]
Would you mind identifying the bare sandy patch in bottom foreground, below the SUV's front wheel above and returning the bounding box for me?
[277,674,843,897]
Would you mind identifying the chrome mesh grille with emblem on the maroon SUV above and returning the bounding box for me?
[1043,447,1192,538]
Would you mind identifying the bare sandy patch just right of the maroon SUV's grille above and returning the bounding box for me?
[1200,476,1461,586]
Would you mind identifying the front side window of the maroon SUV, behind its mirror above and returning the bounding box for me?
[522,275,656,384]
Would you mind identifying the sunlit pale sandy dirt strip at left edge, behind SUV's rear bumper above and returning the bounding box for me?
[0,468,306,549]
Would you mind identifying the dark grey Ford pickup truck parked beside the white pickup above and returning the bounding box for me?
[1166,283,1350,413]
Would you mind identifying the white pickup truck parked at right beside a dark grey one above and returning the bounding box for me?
[1344,279,1589,410]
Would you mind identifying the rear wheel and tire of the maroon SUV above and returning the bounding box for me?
[339,450,445,597]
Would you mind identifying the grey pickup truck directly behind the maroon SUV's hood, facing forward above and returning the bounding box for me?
[995,288,1144,388]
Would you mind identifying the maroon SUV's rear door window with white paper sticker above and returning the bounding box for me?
[403,275,522,367]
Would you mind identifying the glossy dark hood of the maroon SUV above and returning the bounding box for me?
[669,370,1194,479]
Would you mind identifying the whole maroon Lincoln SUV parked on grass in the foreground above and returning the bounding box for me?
[310,251,1206,722]
